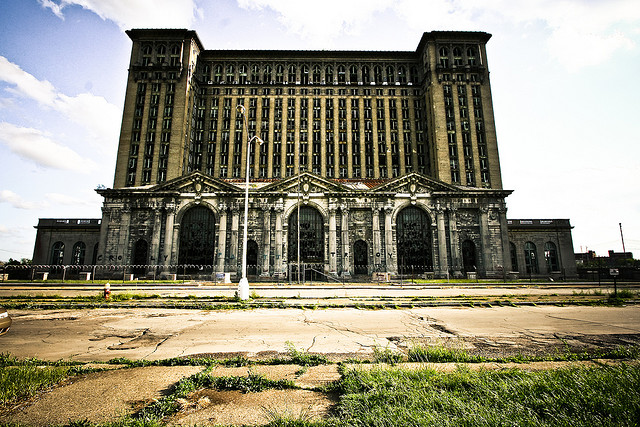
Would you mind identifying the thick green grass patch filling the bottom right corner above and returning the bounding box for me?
[330,365,640,426]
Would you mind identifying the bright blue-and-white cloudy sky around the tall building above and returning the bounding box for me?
[0,0,640,261]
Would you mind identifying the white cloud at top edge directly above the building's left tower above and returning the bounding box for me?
[39,0,201,30]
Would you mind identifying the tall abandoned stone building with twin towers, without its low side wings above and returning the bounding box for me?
[31,30,576,277]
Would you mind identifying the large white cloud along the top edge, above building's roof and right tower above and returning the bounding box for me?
[237,0,640,71]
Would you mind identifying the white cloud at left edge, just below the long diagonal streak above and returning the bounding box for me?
[0,122,97,173]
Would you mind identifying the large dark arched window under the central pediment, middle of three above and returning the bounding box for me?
[287,206,324,263]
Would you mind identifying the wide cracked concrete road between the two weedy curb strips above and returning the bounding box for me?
[0,305,640,361]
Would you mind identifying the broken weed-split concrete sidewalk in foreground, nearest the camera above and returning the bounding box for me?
[0,360,637,427]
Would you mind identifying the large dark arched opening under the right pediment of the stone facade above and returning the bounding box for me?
[396,206,433,274]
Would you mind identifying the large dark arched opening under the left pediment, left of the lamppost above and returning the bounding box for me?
[178,206,216,266]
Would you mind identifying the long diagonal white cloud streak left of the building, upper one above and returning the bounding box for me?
[0,56,121,153]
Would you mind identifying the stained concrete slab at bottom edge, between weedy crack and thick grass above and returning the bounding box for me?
[167,389,336,426]
